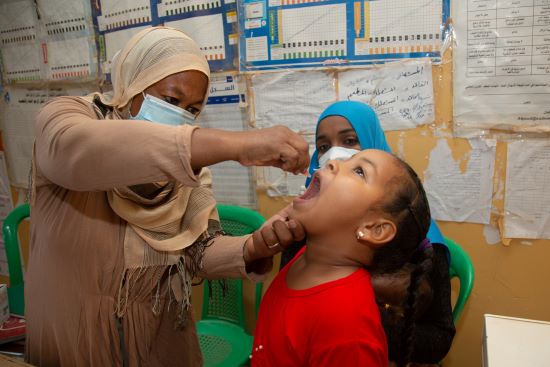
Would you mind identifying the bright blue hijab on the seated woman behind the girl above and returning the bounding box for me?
[306,101,445,249]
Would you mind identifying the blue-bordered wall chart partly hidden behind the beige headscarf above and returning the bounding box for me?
[94,0,238,74]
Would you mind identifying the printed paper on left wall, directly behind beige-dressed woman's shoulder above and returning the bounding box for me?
[0,87,95,188]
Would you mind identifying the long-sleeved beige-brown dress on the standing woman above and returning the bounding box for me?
[25,97,254,366]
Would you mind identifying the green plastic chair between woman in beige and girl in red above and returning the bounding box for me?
[197,204,265,367]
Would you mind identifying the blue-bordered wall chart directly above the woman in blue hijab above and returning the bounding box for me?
[239,0,449,71]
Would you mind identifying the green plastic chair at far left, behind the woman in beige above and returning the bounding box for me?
[3,204,30,316]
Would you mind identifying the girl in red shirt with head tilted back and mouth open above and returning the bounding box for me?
[251,150,430,367]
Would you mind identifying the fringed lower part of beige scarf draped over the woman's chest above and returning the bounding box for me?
[108,168,221,326]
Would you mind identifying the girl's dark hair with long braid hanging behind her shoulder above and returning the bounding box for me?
[369,156,433,367]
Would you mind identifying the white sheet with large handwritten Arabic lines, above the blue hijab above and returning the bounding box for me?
[338,59,434,130]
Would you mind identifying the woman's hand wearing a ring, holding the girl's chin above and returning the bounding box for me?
[244,208,305,274]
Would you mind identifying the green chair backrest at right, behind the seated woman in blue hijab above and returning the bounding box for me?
[445,237,474,323]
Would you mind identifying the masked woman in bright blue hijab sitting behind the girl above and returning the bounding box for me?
[281,101,455,366]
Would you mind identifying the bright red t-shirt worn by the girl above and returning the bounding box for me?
[250,250,388,367]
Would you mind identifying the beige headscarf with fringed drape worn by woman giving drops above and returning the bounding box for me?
[84,27,219,324]
